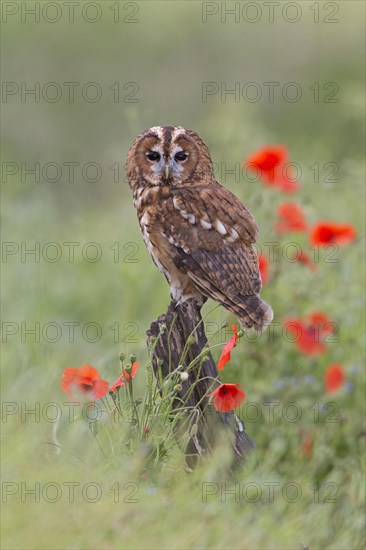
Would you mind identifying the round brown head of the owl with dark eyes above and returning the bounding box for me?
[126,126,213,191]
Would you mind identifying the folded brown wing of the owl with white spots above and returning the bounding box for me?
[162,183,262,301]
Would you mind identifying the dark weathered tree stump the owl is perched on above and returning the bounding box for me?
[147,300,254,468]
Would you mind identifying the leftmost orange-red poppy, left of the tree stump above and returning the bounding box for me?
[61,365,108,400]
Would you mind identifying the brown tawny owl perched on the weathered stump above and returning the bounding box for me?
[126,126,273,331]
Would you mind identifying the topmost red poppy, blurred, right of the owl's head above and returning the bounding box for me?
[244,145,299,193]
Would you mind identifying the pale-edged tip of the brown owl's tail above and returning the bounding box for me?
[235,295,273,332]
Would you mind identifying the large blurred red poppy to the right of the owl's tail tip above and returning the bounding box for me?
[285,312,333,356]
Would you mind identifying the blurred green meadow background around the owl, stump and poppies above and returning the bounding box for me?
[1,0,366,549]
